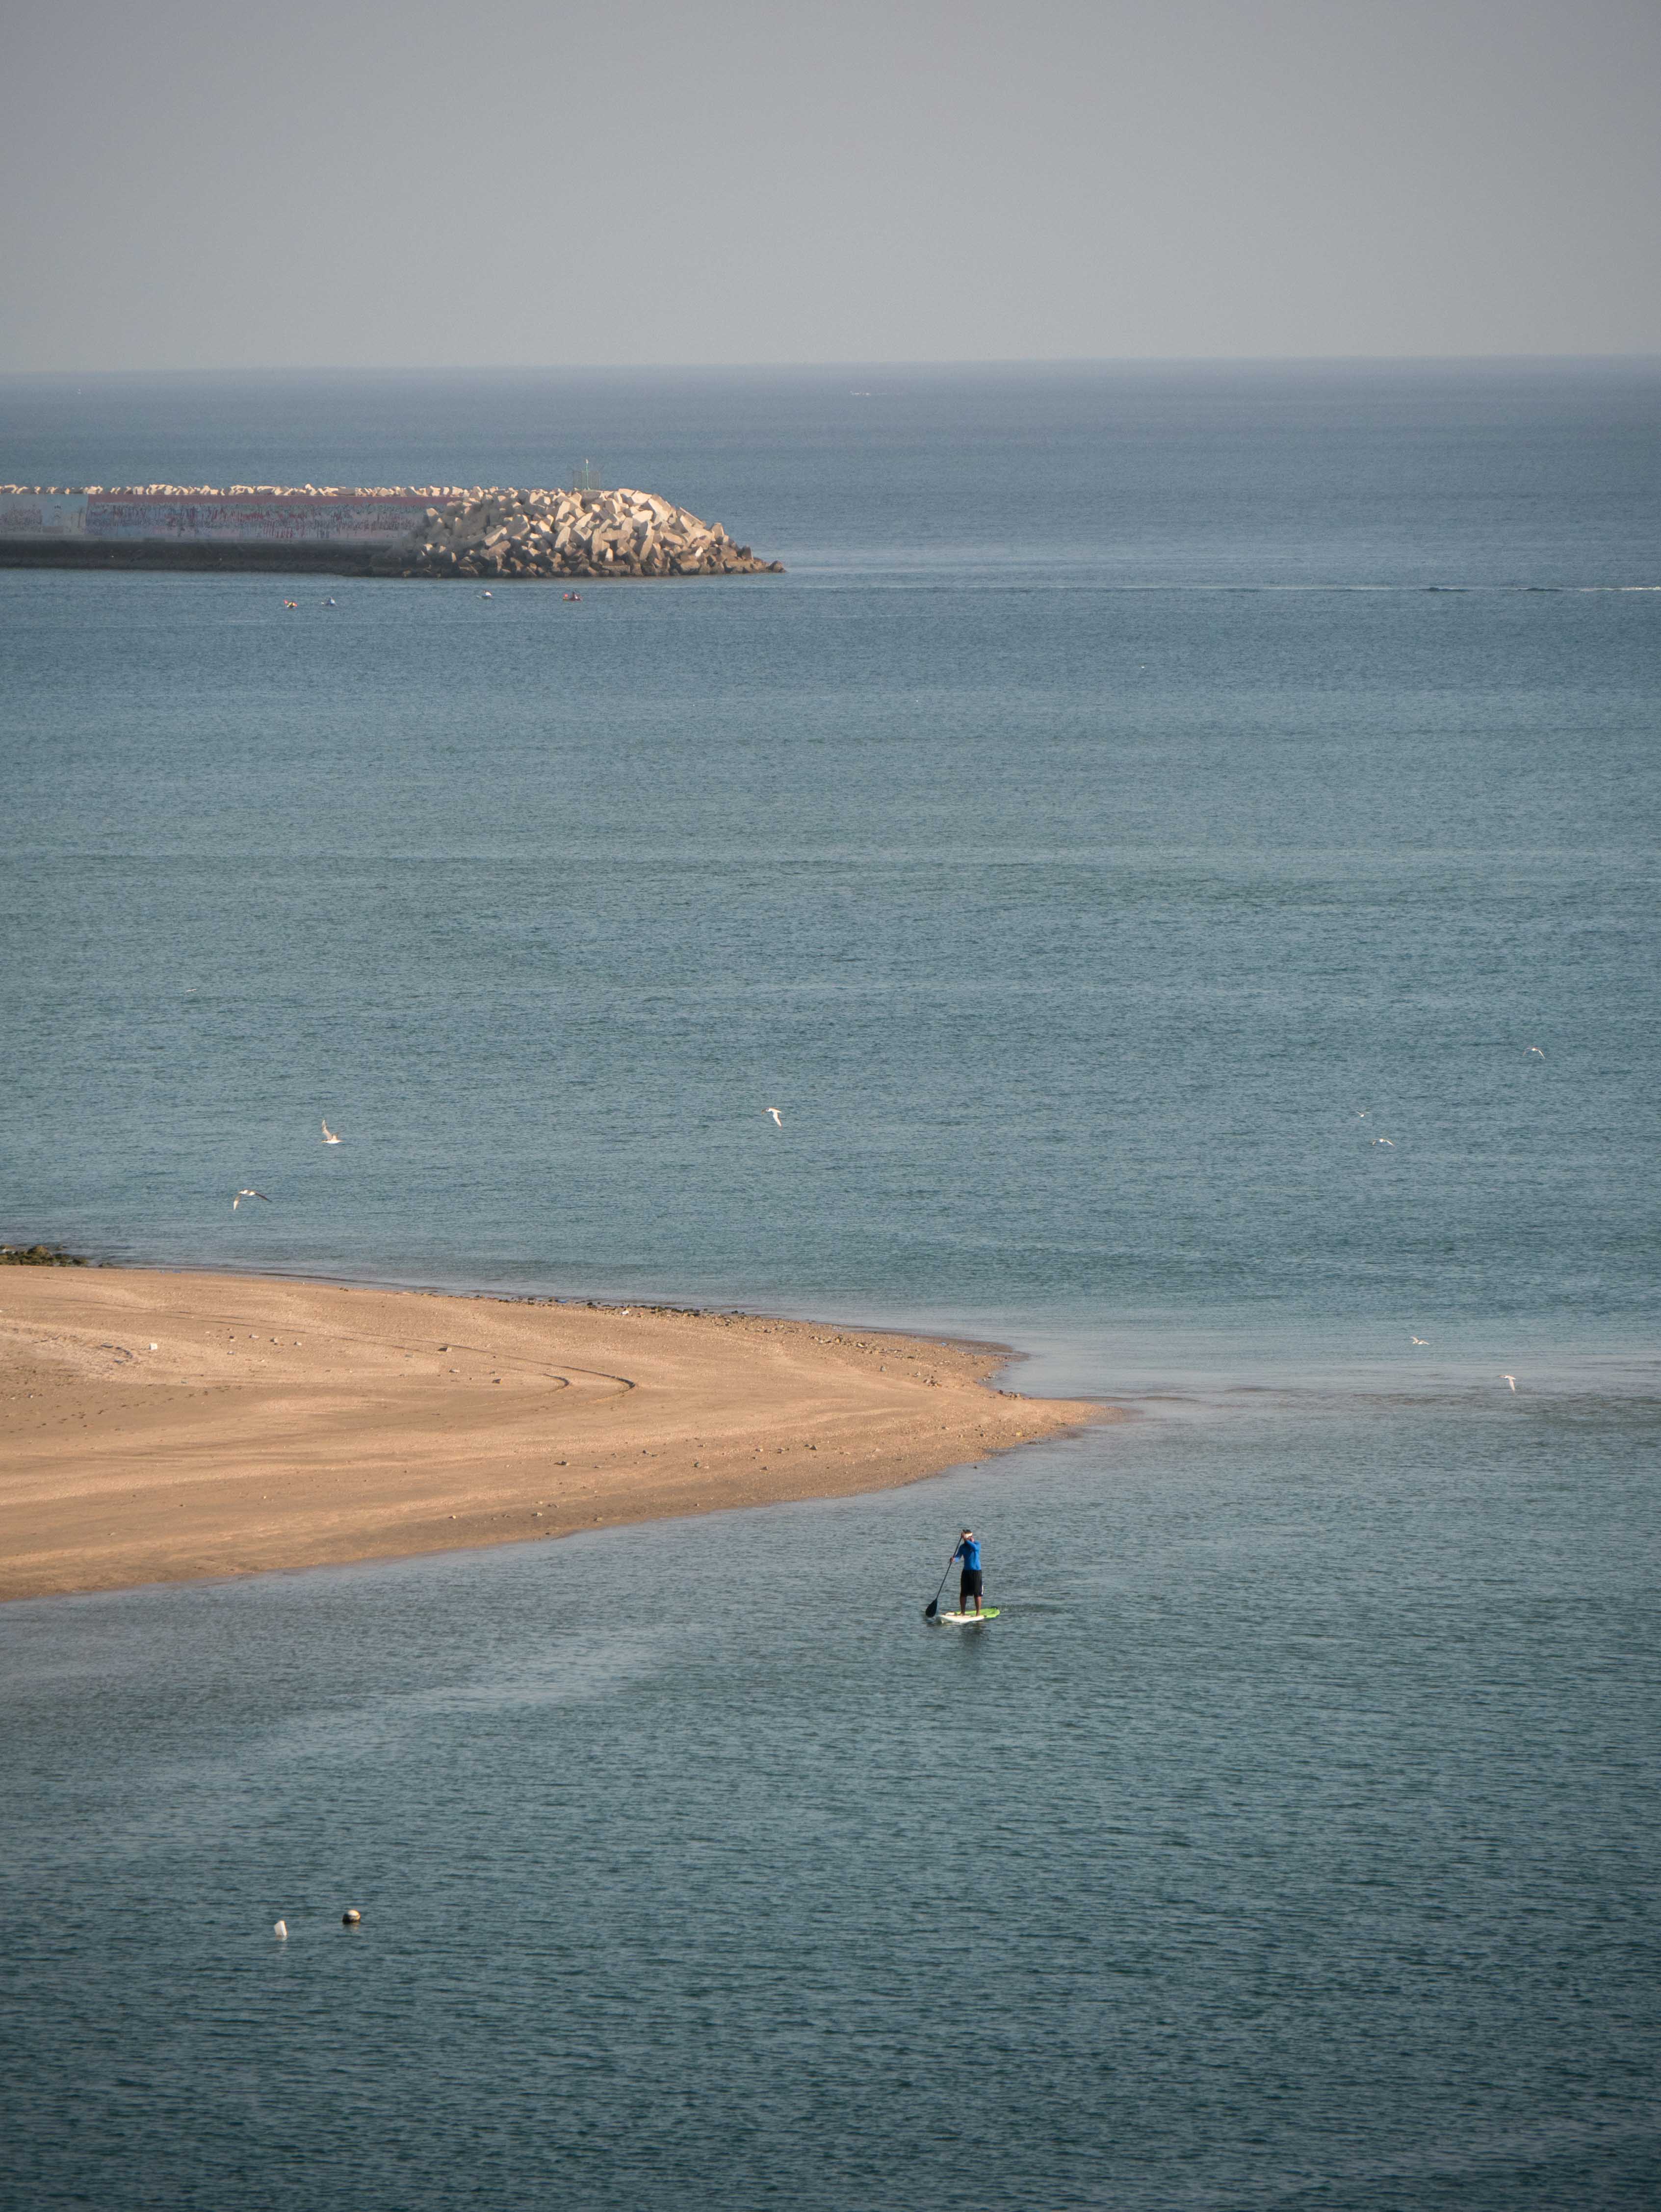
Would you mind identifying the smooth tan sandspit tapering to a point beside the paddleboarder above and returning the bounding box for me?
[0,1268,1113,1599]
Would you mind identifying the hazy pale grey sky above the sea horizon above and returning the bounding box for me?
[0,0,1661,369]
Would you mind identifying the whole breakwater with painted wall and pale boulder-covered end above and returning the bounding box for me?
[0,484,783,582]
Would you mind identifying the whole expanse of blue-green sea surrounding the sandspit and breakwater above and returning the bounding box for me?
[0,363,1661,2212]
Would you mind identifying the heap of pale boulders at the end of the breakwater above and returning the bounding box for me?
[371,491,785,577]
